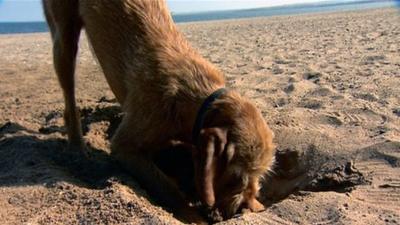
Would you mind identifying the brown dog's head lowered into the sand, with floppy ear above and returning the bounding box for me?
[194,91,275,219]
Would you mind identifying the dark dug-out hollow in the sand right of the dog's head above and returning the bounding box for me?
[261,146,370,205]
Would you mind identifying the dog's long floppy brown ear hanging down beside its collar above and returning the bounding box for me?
[195,128,227,206]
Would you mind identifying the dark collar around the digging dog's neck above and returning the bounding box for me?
[192,88,227,144]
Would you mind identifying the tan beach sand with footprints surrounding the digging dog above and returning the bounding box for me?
[0,9,400,224]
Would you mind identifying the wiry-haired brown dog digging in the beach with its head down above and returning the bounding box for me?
[43,0,274,222]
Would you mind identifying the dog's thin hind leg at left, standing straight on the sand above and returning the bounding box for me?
[43,0,85,150]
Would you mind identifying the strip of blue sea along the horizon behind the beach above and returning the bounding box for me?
[0,0,400,34]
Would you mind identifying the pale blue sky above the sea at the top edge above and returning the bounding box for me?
[0,0,321,22]
